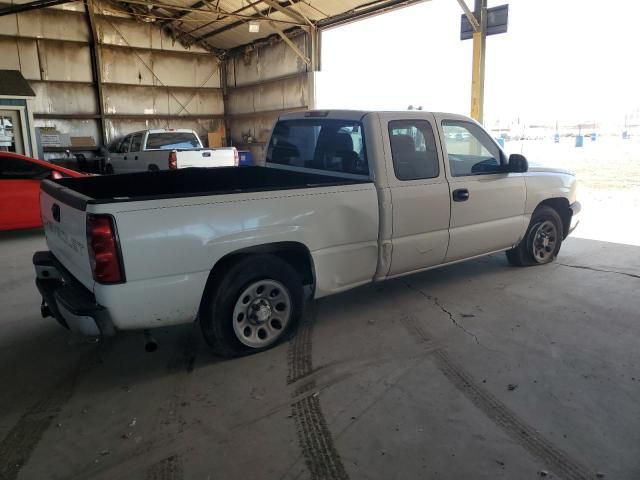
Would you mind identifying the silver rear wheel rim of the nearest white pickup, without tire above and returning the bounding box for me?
[233,279,291,348]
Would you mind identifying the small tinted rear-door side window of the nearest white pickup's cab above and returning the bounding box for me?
[389,120,440,180]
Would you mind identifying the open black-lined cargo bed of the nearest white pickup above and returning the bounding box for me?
[42,167,371,208]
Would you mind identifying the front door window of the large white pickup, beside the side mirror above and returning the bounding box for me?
[442,120,504,177]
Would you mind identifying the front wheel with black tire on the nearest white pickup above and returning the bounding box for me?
[506,205,563,267]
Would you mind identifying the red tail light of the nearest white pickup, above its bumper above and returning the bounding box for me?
[87,214,124,283]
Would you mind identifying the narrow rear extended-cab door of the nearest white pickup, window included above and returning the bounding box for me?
[380,112,450,276]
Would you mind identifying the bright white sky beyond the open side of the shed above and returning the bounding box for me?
[317,0,640,124]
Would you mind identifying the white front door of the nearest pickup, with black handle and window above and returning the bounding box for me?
[438,115,526,262]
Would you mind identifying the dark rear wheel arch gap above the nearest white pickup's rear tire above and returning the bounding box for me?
[200,241,316,316]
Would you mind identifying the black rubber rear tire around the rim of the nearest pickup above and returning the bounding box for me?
[200,254,304,357]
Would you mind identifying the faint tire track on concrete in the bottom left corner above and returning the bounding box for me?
[0,347,103,480]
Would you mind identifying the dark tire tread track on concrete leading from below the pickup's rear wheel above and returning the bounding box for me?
[287,302,349,480]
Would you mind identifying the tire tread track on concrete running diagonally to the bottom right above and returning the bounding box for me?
[400,315,596,480]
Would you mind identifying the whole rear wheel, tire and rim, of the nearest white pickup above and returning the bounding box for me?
[200,255,304,357]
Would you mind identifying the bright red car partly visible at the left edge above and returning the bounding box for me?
[0,152,86,231]
